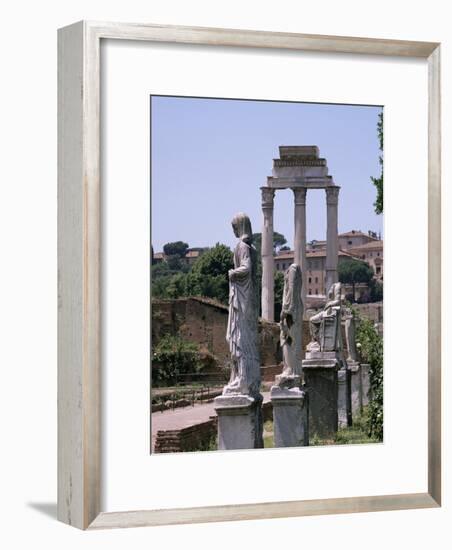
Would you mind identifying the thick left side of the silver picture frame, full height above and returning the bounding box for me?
[57,21,100,529]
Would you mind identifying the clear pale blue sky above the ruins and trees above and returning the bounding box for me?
[151,96,383,252]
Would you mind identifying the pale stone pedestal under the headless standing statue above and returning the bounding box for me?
[270,386,309,447]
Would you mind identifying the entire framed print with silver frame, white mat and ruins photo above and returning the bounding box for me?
[58,22,441,529]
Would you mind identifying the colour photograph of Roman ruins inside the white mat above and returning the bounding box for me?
[150,96,384,453]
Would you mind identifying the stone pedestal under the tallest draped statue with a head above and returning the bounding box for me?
[214,395,264,450]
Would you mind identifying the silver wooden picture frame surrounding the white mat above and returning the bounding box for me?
[58,21,441,529]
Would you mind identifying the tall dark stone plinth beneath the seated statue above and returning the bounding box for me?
[302,351,340,437]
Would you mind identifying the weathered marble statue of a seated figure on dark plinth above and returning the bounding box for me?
[306,283,342,352]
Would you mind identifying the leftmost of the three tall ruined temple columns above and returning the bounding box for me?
[261,187,275,321]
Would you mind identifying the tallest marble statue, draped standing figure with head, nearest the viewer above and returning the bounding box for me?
[223,213,260,397]
